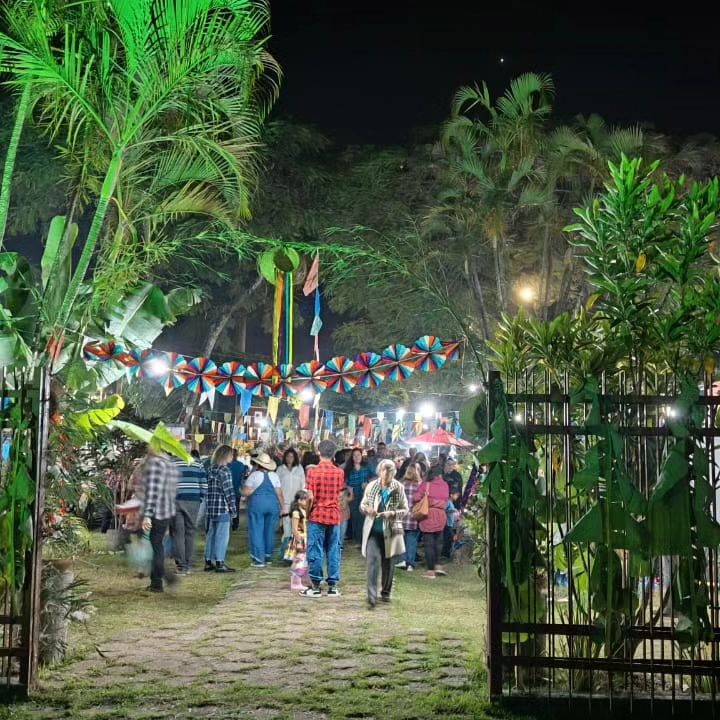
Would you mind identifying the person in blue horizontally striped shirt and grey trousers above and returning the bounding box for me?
[170,447,207,575]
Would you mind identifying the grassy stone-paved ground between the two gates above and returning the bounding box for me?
[0,532,540,720]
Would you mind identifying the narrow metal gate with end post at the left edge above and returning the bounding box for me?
[0,369,49,696]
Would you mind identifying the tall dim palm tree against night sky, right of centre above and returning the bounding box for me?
[433,73,553,322]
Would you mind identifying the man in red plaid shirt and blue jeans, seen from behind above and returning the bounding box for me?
[300,440,345,598]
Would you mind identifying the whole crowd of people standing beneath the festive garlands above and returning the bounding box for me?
[131,440,477,608]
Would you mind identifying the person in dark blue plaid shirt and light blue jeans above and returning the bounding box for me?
[205,445,237,572]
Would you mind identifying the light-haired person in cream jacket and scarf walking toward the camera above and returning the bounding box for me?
[360,460,408,609]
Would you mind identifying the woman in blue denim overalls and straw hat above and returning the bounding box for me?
[242,453,285,568]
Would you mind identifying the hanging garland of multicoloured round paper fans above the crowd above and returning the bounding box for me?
[83,335,461,402]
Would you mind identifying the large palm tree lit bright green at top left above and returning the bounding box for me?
[0,0,279,328]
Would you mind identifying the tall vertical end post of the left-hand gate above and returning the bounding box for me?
[20,369,50,695]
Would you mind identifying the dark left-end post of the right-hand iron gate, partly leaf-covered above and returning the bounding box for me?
[485,370,503,699]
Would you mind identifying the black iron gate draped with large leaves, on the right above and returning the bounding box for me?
[487,370,720,717]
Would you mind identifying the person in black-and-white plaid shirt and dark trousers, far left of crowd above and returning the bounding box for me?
[138,450,177,592]
